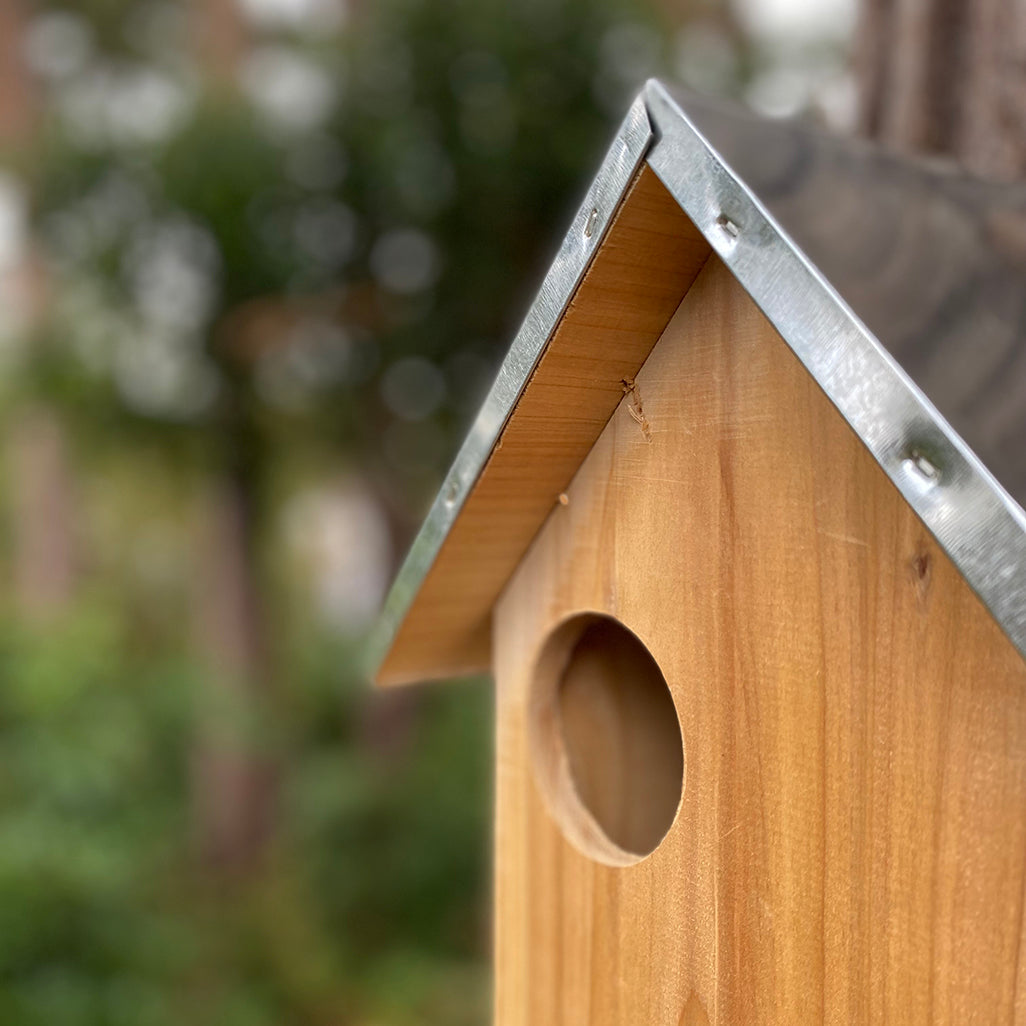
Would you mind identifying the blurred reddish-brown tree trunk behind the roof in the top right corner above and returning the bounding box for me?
[856,0,1026,181]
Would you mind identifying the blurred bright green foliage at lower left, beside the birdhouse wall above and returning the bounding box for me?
[0,605,490,1026]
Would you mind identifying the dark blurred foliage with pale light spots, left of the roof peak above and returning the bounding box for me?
[20,0,669,508]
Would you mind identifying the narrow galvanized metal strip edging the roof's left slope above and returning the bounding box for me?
[367,95,653,674]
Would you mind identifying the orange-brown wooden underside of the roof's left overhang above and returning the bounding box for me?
[378,167,709,683]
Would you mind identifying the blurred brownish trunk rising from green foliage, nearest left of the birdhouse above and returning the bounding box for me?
[193,474,274,869]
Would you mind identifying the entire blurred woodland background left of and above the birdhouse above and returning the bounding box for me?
[0,0,856,1026]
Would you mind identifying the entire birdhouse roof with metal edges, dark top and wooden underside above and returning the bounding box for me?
[374,83,1026,683]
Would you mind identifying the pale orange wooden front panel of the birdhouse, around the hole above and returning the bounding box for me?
[495,260,1026,1026]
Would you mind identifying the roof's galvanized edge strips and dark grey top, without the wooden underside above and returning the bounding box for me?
[371,81,1026,673]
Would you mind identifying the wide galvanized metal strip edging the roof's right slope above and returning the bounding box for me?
[643,81,1026,657]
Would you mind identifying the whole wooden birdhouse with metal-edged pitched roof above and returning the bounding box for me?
[378,82,1026,1026]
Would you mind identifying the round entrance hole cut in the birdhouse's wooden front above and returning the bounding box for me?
[529,613,684,865]
